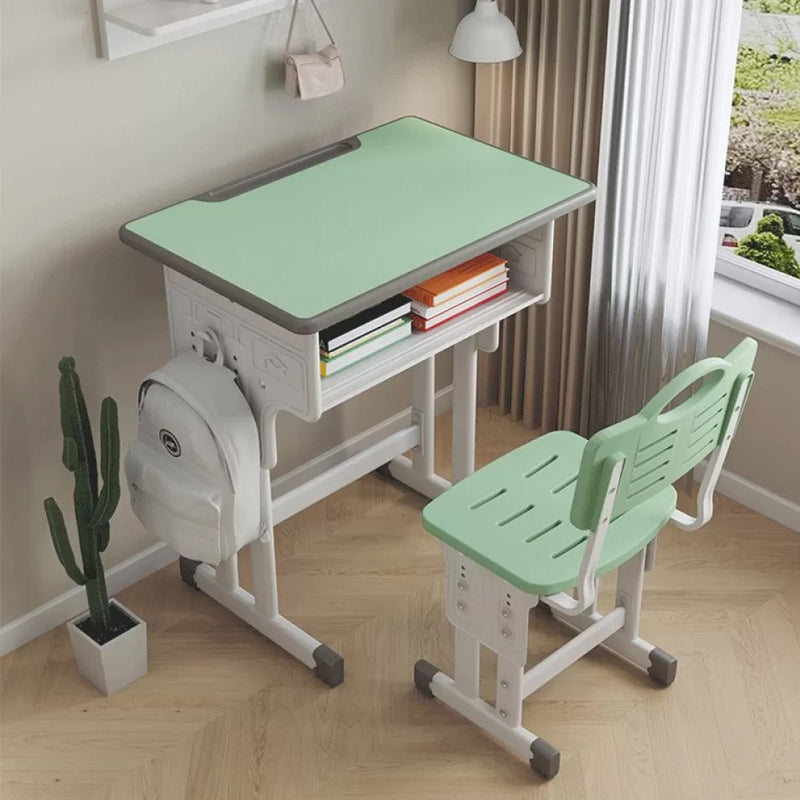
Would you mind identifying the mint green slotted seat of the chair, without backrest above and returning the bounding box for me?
[422,431,677,595]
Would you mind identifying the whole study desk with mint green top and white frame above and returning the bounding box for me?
[120,117,595,686]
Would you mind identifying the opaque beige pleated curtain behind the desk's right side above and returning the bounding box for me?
[475,0,609,431]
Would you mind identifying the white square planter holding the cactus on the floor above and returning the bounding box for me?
[67,600,147,695]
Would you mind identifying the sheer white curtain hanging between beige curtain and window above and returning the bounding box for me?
[581,0,741,432]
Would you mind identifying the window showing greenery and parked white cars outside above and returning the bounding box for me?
[717,0,800,302]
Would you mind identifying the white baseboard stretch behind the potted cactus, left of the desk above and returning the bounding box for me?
[0,542,178,656]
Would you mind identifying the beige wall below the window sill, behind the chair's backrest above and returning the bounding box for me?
[708,322,800,506]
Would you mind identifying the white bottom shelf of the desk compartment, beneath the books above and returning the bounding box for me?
[321,289,544,411]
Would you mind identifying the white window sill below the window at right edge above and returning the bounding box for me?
[711,273,800,356]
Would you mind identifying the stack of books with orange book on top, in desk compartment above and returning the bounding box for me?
[405,253,508,331]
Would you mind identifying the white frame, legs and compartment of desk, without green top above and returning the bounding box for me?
[164,222,556,686]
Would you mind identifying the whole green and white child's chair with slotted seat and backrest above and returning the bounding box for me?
[414,339,757,778]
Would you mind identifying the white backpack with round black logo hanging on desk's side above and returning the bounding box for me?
[125,352,261,565]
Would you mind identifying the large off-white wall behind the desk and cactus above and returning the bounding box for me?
[0,0,473,624]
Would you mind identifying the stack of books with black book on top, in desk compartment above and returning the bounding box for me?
[319,294,411,378]
